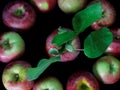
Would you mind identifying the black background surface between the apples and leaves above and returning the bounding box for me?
[0,0,120,90]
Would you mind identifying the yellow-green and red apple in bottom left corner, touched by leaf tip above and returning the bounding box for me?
[2,60,34,90]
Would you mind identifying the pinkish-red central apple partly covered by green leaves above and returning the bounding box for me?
[46,28,80,62]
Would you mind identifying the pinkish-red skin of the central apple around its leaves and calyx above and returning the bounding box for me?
[46,29,80,62]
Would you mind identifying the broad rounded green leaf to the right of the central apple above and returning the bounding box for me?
[84,28,113,58]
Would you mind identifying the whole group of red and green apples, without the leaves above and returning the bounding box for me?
[0,0,120,90]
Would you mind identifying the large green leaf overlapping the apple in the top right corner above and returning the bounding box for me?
[72,2,102,34]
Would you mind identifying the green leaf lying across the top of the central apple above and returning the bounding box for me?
[52,29,76,46]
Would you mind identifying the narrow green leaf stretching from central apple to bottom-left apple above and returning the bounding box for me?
[28,57,60,81]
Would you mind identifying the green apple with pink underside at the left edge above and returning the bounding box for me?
[0,31,25,63]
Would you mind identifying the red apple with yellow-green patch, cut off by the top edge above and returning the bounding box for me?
[32,0,57,12]
